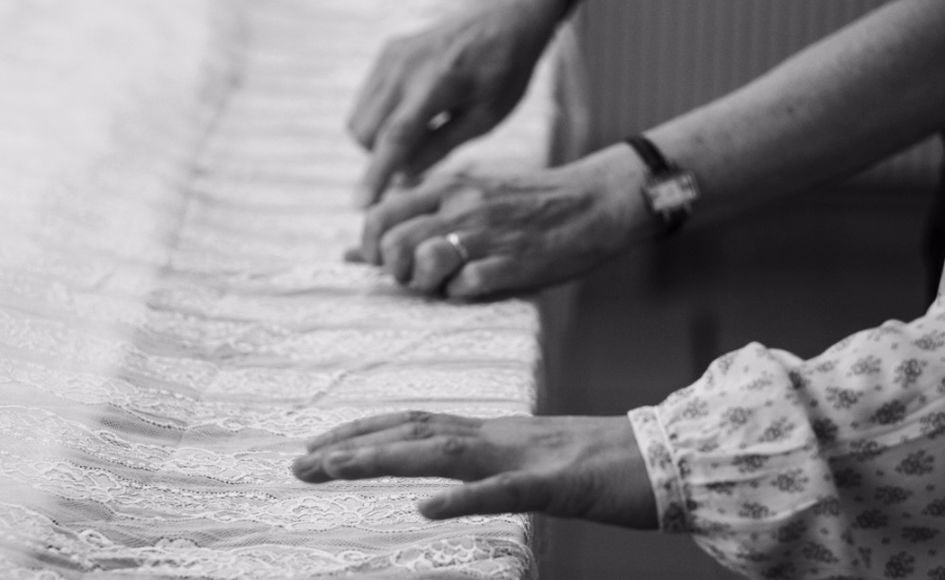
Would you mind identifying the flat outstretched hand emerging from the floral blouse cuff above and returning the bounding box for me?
[293,412,656,528]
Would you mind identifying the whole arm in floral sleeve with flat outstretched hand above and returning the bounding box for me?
[294,298,945,578]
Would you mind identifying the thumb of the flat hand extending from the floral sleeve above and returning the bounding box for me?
[419,471,554,520]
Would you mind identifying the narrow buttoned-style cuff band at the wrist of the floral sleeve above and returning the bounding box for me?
[627,407,689,533]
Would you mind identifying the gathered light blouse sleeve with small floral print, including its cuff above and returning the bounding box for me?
[629,298,945,580]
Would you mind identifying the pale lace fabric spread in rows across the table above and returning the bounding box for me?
[0,0,548,579]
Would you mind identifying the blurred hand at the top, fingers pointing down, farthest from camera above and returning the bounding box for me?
[348,0,568,205]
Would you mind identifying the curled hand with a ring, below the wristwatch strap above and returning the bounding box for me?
[348,145,655,298]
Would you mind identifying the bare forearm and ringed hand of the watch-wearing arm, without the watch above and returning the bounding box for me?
[352,0,945,298]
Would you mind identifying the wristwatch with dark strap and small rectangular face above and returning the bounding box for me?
[624,135,699,235]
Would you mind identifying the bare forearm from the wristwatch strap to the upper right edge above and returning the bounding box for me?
[647,0,945,222]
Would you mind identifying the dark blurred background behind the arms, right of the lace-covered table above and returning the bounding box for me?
[537,0,942,580]
